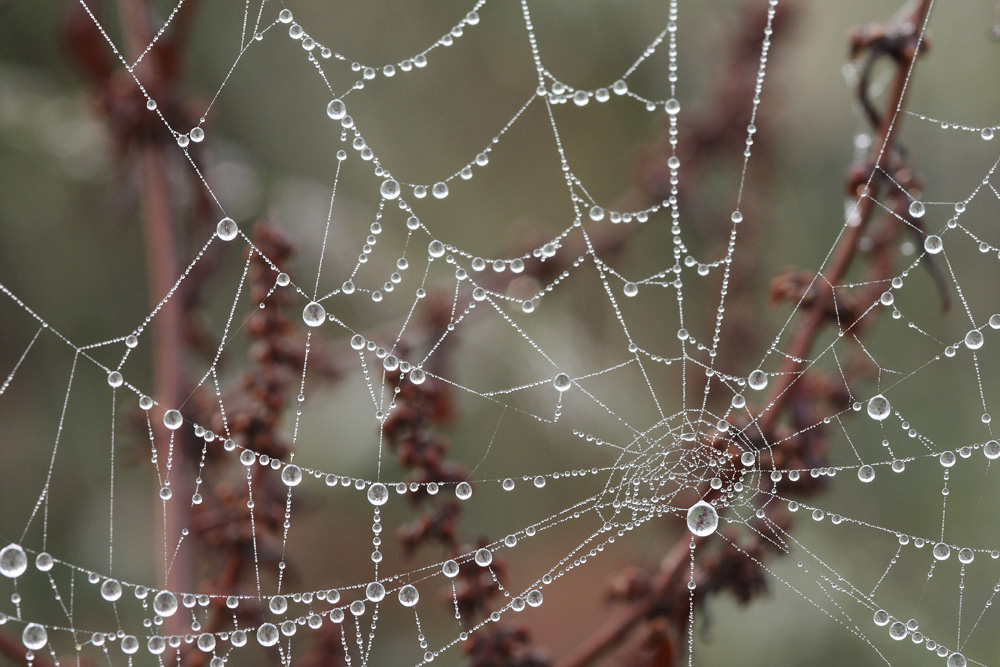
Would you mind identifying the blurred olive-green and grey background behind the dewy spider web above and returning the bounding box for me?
[0,0,1000,665]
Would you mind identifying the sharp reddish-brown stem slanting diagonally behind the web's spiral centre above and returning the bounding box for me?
[557,0,931,667]
